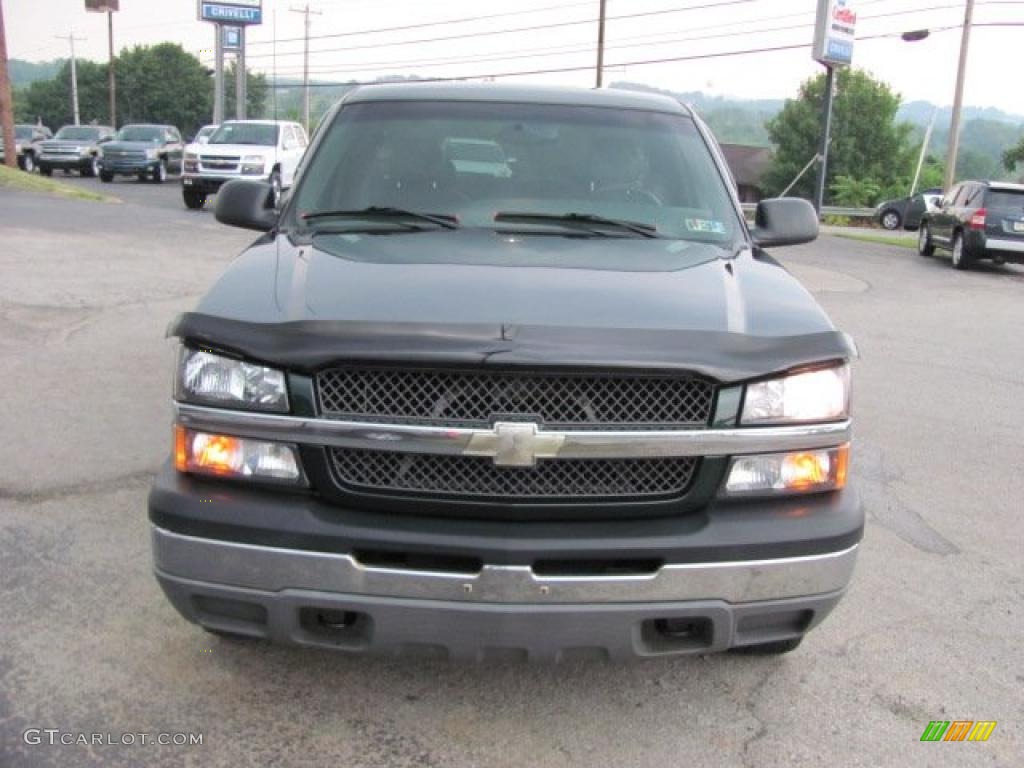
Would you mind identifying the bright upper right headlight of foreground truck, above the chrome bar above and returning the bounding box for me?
[739,364,850,425]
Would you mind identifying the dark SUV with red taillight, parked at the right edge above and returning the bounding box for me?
[918,181,1024,269]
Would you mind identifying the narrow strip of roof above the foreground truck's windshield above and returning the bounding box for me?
[345,83,691,115]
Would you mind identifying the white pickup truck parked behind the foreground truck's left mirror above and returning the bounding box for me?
[181,120,309,209]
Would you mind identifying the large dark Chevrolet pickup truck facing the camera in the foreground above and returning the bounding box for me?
[148,84,863,660]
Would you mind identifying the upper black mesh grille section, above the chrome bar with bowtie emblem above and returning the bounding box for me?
[316,368,715,430]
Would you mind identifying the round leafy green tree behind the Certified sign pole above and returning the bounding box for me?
[765,70,913,198]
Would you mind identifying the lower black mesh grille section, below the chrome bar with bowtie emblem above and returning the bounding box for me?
[328,449,699,502]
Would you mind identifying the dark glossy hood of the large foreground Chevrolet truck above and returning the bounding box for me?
[198,229,833,336]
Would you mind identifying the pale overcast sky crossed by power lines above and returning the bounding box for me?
[3,0,1024,115]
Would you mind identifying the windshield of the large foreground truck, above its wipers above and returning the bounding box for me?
[285,101,740,245]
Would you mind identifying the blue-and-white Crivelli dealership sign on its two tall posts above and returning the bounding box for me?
[197,0,263,124]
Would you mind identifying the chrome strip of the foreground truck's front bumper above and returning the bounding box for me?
[153,526,857,604]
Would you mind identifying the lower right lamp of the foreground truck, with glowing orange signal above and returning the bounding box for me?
[722,445,850,497]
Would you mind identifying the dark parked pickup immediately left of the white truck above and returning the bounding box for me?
[99,124,184,184]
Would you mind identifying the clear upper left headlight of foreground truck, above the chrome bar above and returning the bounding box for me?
[175,347,288,413]
